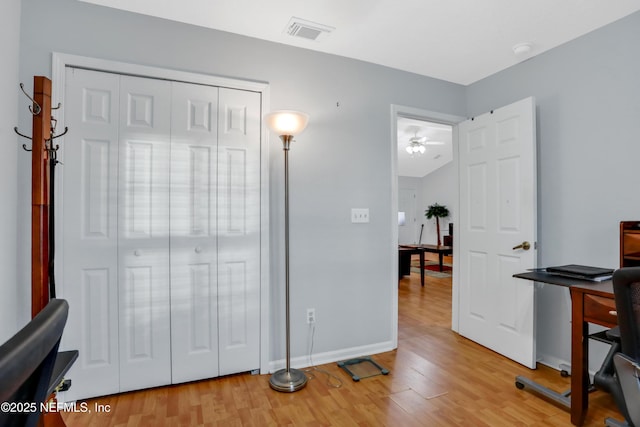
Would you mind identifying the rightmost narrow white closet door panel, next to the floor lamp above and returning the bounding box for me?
[218,88,261,375]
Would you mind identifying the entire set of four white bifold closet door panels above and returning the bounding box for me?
[62,68,260,400]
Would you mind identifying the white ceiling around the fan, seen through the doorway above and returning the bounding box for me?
[397,117,453,178]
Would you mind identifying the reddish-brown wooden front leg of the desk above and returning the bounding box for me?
[571,292,589,426]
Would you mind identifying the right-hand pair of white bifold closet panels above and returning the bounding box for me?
[170,83,260,383]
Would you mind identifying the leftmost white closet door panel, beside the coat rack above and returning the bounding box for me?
[61,68,120,401]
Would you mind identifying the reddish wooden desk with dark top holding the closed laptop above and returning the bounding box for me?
[514,271,617,426]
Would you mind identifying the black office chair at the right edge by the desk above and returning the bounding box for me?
[605,267,640,426]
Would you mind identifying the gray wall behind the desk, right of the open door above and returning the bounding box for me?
[467,13,640,372]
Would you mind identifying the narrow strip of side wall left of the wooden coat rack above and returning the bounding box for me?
[0,0,21,343]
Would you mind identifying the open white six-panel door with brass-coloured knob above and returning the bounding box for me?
[458,98,537,368]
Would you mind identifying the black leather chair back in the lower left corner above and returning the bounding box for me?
[0,299,69,427]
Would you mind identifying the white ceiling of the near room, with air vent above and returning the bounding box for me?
[81,0,640,85]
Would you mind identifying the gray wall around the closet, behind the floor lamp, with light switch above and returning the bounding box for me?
[19,0,466,360]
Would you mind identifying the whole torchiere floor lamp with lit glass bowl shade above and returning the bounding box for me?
[265,110,309,393]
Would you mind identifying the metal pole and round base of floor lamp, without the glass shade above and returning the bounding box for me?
[269,135,307,393]
